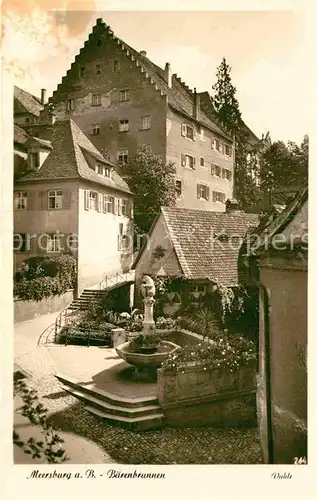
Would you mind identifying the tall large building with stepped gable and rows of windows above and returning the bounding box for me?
[42,19,234,211]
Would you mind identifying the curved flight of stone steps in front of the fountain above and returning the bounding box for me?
[55,375,164,431]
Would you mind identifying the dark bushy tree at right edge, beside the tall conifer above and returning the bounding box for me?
[260,135,309,191]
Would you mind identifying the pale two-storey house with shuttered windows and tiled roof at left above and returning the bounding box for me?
[14,119,133,294]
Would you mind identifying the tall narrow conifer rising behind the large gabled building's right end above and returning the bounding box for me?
[213,58,260,210]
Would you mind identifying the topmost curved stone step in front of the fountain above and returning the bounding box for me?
[55,374,158,408]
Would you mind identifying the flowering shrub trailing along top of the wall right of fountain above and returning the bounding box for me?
[162,337,256,373]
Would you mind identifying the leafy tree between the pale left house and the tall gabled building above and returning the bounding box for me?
[122,146,176,234]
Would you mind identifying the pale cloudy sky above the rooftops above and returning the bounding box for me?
[2,0,309,143]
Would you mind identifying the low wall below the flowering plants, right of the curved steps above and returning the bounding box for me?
[157,363,257,427]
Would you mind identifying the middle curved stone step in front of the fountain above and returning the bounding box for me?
[63,386,161,419]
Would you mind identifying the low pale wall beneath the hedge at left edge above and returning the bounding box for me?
[14,290,74,323]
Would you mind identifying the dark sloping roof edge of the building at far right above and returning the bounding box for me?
[251,187,308,253]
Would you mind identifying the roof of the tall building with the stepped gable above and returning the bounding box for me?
[49,19,231,141]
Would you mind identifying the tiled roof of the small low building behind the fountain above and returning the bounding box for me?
[162,208,259,286]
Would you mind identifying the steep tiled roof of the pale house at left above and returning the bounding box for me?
[19,119,131,193]
